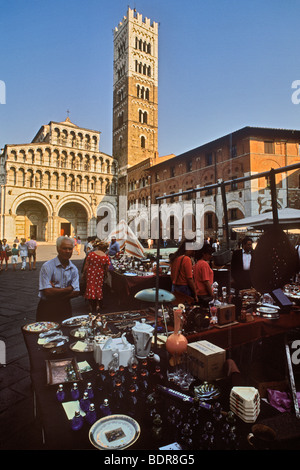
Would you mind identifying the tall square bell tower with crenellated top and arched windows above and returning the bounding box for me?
[112,8,158,219]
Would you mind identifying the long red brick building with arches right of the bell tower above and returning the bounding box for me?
[127,127,300,244]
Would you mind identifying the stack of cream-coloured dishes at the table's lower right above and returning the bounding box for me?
[230,387,260,423]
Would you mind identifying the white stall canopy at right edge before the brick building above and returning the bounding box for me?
[228,207,300,231]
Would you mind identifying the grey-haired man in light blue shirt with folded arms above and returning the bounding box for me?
[36,237,80,321]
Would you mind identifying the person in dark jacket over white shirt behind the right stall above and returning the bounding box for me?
[231,237,252,290]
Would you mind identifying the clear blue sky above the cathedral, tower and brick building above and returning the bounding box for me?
[0,0,300,155]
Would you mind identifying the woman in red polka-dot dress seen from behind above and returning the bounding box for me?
[83,239,110,313]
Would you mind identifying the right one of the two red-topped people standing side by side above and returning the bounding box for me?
[194,243,214,303]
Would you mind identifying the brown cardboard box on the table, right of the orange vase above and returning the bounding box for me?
[187,340,226,381]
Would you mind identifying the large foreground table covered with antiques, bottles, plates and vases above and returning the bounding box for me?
[22,286,300,451]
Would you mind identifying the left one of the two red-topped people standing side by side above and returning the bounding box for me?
[170,240,197,300]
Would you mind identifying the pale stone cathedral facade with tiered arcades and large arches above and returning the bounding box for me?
[0,118,118,242]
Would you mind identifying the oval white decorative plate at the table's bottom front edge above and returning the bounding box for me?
[89,415,141,450]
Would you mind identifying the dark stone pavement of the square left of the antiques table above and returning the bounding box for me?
[0,244,116,450]
